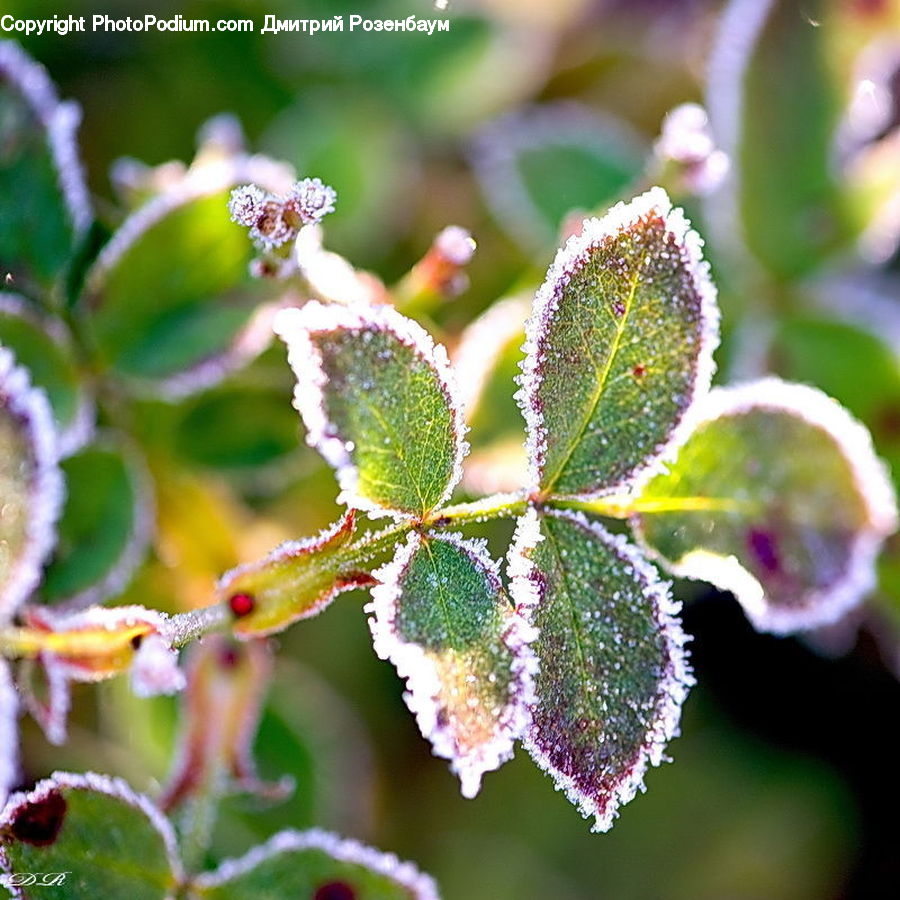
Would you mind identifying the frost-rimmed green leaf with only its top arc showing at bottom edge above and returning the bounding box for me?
[190,829,438,900]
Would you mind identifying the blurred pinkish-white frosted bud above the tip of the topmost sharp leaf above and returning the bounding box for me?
[654,103,729,194]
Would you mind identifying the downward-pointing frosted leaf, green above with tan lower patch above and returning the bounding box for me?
[369,532,534,797]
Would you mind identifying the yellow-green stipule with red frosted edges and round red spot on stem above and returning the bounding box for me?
[216,510,372,638]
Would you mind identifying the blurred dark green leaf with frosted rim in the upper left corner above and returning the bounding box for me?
[0,41,92,290]
